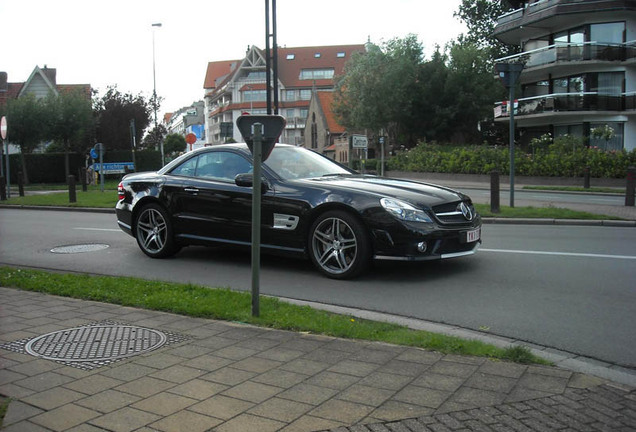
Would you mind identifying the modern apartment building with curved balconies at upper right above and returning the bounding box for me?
[494,0,636,150]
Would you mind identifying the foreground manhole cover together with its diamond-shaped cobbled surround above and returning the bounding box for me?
[0,320,190,370]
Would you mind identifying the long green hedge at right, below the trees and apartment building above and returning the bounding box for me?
[387,139,636,178]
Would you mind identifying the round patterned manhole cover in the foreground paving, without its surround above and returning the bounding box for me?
[25,325,167,362]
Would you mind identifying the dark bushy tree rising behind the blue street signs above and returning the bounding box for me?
[95,86,151,150]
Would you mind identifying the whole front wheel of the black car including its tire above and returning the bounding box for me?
[309,210,371,279]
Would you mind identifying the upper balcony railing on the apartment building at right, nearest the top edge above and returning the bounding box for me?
[496,41,636,69]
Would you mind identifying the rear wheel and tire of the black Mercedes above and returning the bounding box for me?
[135,204,179,258]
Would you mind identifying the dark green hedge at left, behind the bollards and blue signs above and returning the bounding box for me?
[3,150,161,184]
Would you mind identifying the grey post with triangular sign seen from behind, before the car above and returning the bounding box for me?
[236,115,285,317]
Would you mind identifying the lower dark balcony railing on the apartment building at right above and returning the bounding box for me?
[495,92,636,118]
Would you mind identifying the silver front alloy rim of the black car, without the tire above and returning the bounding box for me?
[312,217,358,275]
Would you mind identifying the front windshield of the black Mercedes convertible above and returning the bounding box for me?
[264,146,353,180]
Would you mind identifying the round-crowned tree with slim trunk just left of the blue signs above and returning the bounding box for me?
[44,92,94,178]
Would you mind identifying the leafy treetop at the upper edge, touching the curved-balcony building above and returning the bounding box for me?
[455,0,519,61]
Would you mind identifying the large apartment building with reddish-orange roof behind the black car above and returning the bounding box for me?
[204,45,365,145]
